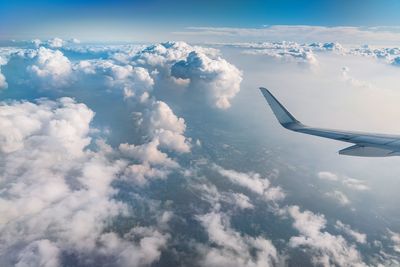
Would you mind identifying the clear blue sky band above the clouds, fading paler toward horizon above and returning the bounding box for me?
[0,0,400,39]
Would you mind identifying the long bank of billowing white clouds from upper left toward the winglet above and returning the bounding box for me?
[2,41,242,109]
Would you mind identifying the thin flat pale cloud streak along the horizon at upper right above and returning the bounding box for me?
[174,25,400,45]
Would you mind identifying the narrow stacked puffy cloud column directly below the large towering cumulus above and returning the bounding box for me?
[119,100,190,185]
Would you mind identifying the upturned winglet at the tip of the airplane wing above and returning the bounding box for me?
[260,87,300,128]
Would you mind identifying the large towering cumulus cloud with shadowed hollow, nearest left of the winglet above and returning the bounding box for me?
[129,42,242,109]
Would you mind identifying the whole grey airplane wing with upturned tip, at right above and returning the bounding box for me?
[260,87,400,157]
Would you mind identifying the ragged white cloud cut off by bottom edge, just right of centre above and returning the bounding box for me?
[197,211,278,267]
